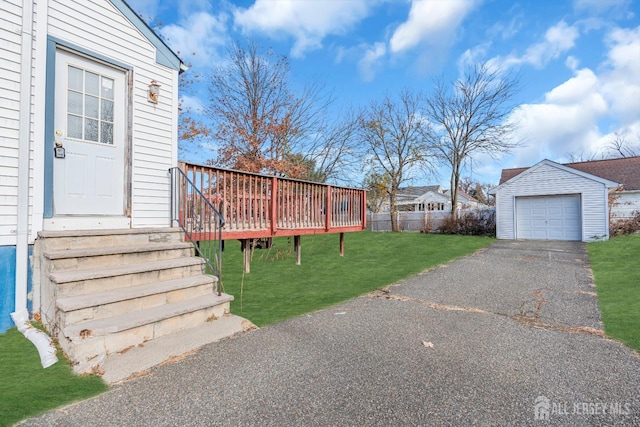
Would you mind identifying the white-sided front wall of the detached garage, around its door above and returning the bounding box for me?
[496,165,609,241]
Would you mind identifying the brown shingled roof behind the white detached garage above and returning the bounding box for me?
[500,156,640,191]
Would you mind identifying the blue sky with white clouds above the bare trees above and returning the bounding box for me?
[129,0,640,186]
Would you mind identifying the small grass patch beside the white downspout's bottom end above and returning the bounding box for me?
[0,328,108,426]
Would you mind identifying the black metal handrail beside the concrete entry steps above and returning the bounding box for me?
[169,167,225,295]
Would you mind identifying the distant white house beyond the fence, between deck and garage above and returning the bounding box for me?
[390,185,485,212]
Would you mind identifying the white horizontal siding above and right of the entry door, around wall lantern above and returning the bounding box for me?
[48,0,178,227]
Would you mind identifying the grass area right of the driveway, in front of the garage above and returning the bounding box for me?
[588,235,640,350]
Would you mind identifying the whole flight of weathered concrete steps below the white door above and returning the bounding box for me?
[34,228,233,372]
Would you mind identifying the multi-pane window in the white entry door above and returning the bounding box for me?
[67,65,114,145]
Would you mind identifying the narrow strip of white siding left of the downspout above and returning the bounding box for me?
[0,0,22,246]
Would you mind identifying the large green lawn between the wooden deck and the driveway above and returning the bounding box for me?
[222,231,495,326]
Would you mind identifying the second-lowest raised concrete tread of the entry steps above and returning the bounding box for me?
[56,274,218,313]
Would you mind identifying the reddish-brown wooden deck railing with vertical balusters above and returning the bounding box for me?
[179,163,366,240]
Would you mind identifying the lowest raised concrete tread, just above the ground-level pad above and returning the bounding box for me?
[63,294,233,340]
